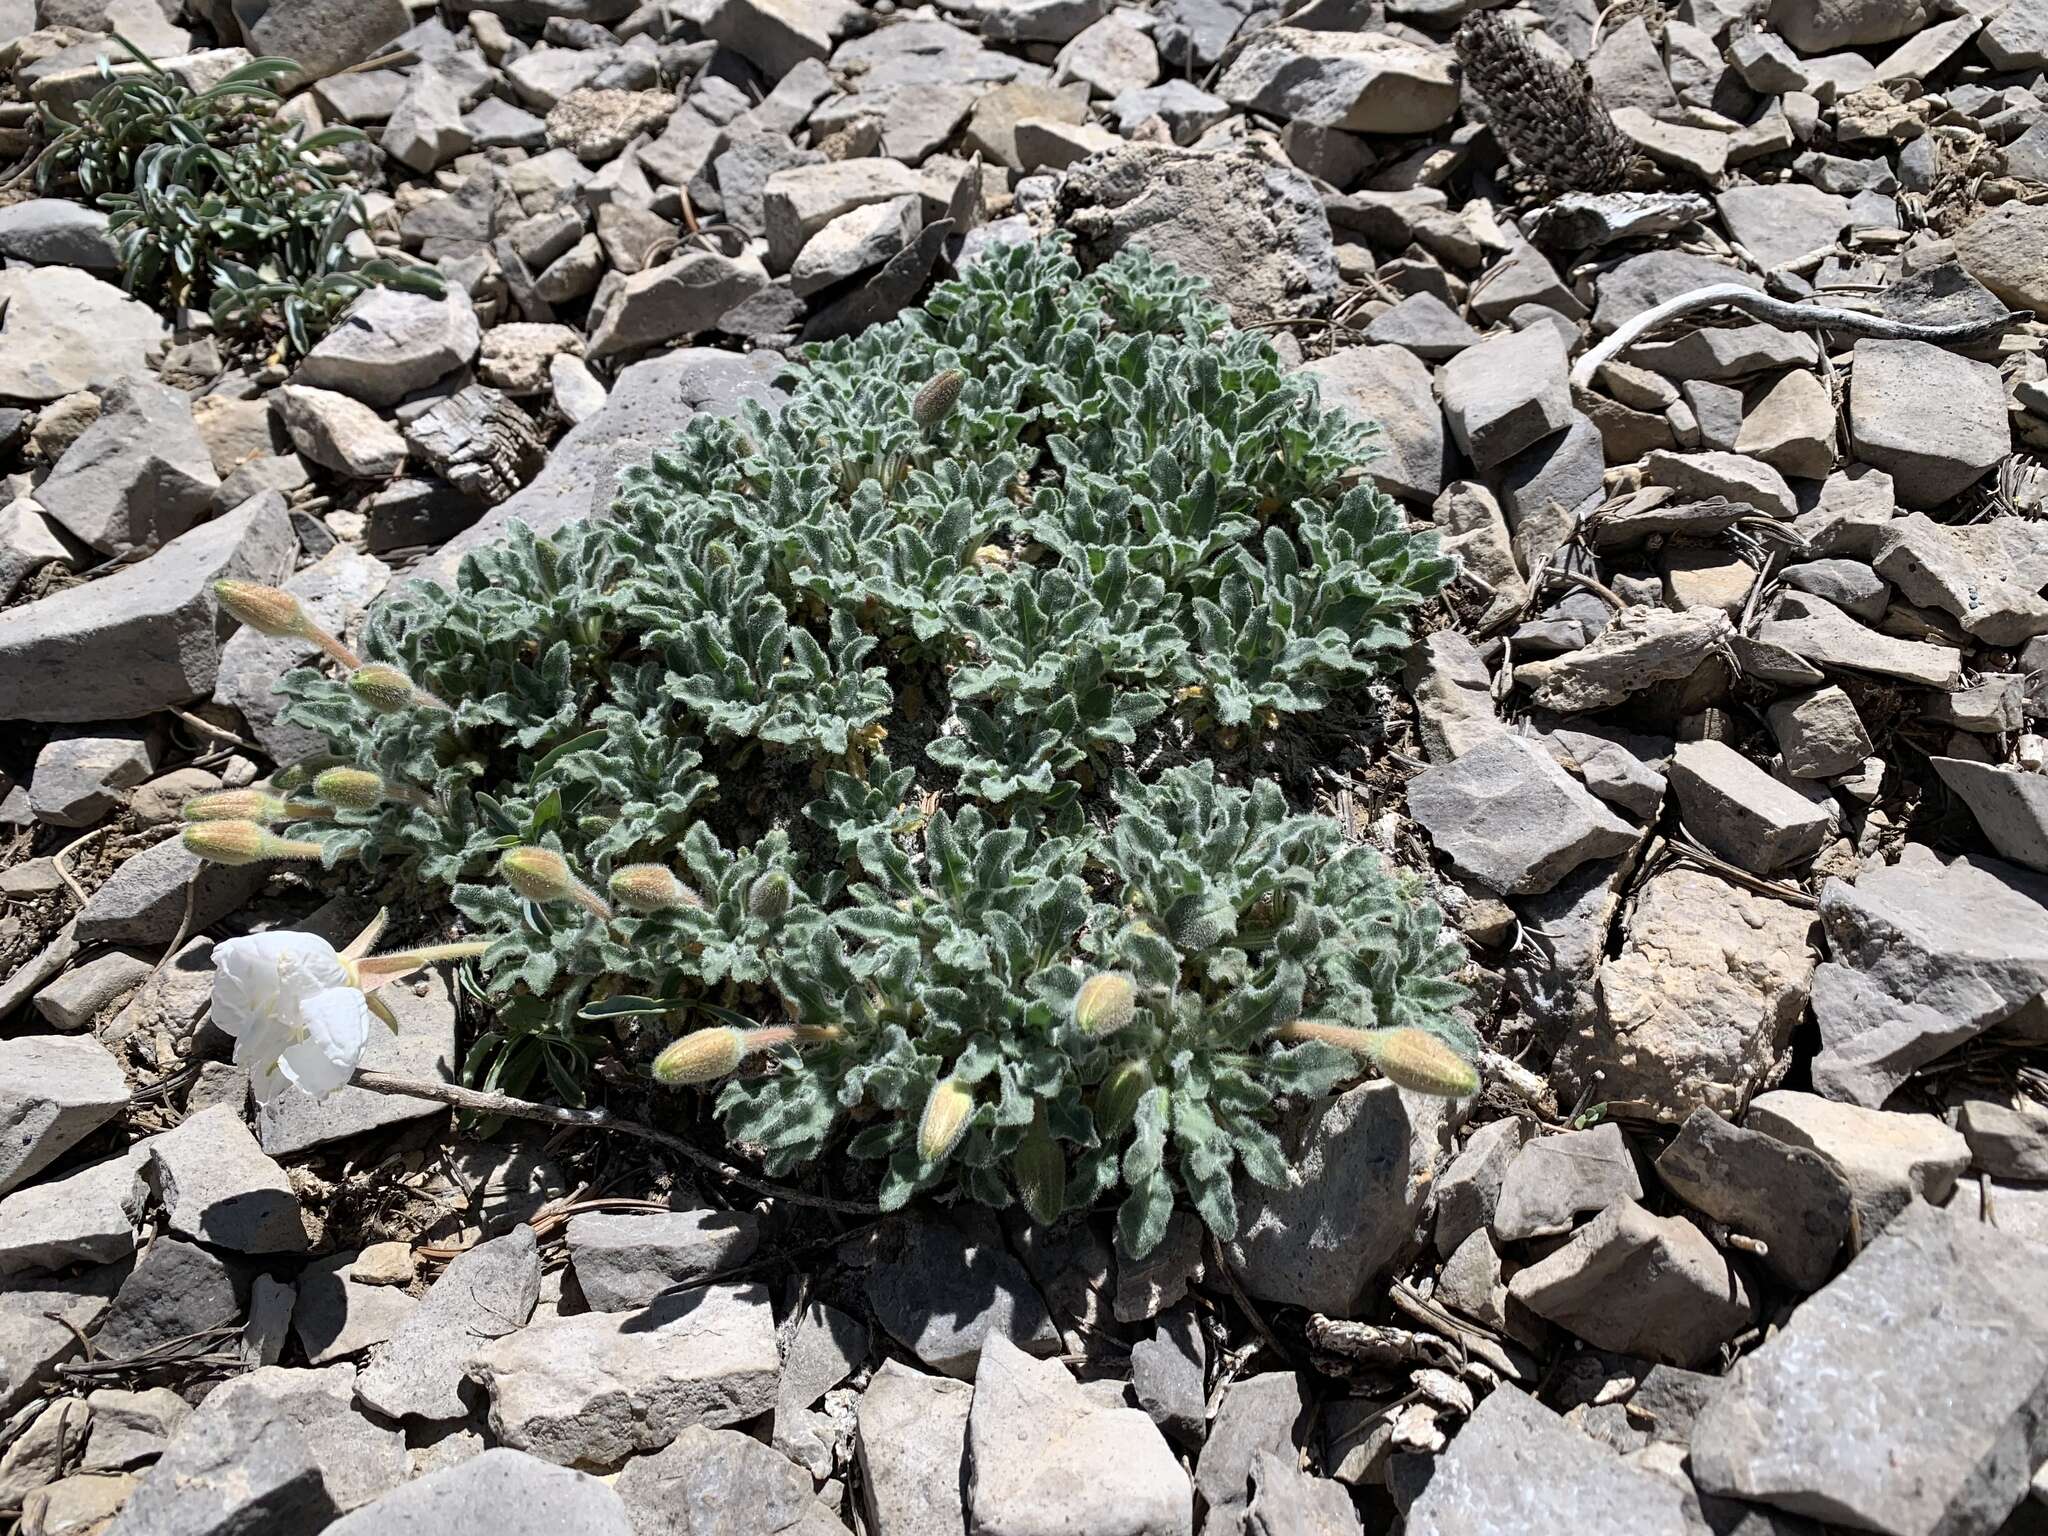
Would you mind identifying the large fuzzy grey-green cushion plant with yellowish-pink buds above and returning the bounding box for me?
[188,242,1477,1253]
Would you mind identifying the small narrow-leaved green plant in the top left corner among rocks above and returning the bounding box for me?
[37,37,446,352]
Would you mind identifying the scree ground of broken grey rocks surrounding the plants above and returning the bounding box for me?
[0,0,2048,1536]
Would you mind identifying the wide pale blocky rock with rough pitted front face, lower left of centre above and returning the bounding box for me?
[471,1286,780,1466]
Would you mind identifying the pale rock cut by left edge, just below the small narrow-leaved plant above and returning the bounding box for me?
[0,266,170,406]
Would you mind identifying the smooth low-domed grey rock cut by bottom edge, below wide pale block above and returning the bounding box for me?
[313,1448,637,1536]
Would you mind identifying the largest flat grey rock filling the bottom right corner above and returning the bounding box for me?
[1692,1206,2048,1536]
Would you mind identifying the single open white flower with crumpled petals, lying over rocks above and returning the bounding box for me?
[213,932,371,1102]
